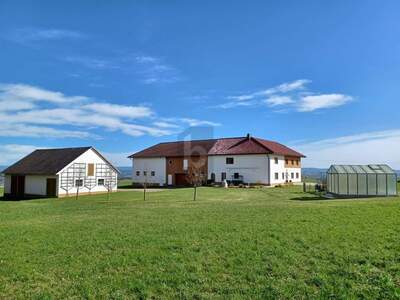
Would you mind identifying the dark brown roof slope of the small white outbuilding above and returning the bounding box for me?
[2,147,91,175]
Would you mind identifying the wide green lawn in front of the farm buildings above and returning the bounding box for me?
[0,187,400,299]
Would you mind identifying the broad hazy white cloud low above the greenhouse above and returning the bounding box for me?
[293,129,400,169]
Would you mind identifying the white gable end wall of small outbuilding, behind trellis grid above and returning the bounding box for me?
[58,149,118,195]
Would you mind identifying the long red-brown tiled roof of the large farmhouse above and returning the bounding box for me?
[129,137,304,158]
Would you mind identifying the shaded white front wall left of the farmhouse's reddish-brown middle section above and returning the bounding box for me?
[132,157,167,185]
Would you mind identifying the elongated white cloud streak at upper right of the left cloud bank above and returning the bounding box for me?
[84,103,153,119]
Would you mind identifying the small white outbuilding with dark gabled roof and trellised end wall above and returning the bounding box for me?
[2,147,119,199]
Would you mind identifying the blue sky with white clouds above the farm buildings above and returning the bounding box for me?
[0,1,400,168]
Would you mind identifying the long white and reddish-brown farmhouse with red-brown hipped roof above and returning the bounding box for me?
[130,135,304,186]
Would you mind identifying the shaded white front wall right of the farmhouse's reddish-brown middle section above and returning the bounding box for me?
[208,154,269,184]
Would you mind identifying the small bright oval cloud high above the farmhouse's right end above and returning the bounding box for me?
[298,94,353,112]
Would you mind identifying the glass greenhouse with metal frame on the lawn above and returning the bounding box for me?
[326,165,397,197]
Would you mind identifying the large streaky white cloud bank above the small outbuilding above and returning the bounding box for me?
[0,84,219,138]
